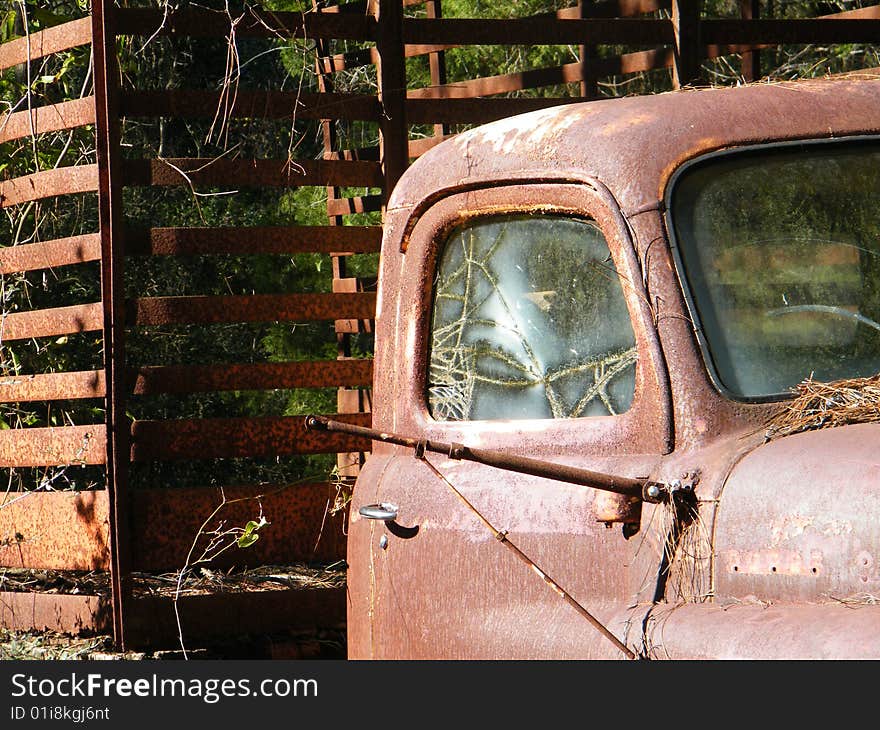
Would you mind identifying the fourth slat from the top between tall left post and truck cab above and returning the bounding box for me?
[124,226,382,262]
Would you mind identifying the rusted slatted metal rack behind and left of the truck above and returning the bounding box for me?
[0,0,880,646]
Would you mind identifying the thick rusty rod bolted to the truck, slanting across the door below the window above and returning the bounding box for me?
[305,416,669,504]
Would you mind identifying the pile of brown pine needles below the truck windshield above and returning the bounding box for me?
[764,374,880,439]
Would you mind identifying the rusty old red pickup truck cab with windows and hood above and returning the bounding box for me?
[311,74,880,659]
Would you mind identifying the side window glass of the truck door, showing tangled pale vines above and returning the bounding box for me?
[427,215,637,421]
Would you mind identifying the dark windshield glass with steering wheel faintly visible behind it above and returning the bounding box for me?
[670,142,880,398]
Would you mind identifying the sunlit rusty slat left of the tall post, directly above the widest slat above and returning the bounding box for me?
[0,425,107,467]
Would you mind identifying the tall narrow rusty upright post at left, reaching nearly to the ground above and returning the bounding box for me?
[92,0,131,649]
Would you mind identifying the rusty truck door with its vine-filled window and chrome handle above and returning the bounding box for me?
[348,184,671,659]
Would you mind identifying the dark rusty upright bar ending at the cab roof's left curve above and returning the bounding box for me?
[374,0,409,206]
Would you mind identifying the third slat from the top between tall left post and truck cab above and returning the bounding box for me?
[123,158,383,189]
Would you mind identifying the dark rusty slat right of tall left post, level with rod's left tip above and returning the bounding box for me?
[131,413,371,461]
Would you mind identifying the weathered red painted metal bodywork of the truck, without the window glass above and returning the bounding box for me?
[348,75,880,659]
